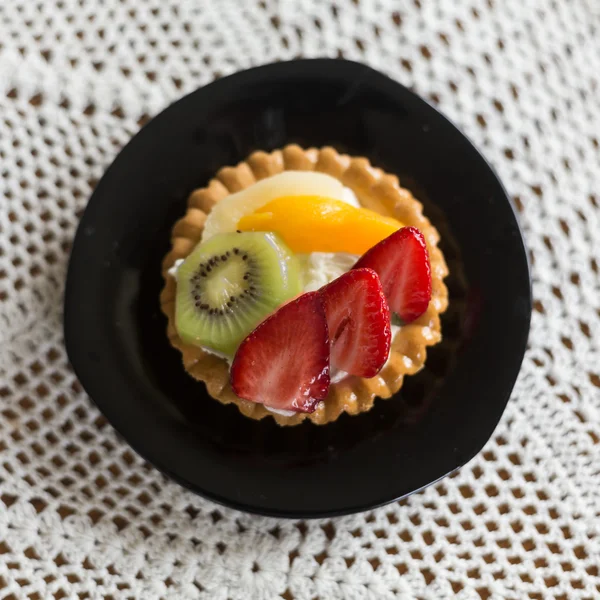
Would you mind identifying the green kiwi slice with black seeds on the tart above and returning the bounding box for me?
[175,232,302,356]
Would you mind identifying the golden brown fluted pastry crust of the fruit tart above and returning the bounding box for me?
[160,145,448,425]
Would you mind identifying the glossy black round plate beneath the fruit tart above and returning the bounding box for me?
[65,59,531,517]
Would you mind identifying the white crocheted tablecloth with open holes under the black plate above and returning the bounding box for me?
[0,0,600,600]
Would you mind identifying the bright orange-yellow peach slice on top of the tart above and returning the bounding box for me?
[238,196,402,254]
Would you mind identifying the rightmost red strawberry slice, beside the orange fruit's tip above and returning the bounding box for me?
[354,227,431,323]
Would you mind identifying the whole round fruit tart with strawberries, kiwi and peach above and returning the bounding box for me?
[161,145,448,425]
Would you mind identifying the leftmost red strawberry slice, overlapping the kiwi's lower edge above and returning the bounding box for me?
[231,292,329,413]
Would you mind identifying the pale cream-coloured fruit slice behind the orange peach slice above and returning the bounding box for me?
[202,171,344,241]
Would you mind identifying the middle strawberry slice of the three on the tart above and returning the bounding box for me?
[321,269,391,377]
